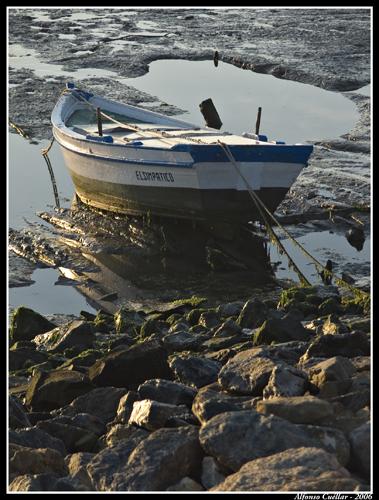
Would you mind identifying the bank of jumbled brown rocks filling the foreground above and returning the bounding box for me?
[9,285,371,492]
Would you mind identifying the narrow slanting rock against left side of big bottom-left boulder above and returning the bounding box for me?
[87,427,148,491]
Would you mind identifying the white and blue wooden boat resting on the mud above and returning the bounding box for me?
[51,83,313,223]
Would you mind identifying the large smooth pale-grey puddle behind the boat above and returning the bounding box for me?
[126,60,359,143]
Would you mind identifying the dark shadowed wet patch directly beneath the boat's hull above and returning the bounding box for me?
[67,207,274,313]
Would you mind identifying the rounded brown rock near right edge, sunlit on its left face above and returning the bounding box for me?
[309,356,356,397]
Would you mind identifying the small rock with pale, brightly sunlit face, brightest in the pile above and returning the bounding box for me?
[129,399,188,431]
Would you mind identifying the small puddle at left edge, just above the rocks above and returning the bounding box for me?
[9,269,96,315]
